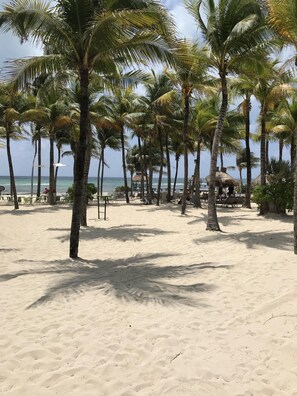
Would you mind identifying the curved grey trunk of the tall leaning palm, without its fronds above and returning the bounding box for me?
[206,70,228,231]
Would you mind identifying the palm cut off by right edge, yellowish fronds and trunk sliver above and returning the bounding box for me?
[266,0,297,254]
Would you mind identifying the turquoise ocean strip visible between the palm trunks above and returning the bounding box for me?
[0,176,187,194]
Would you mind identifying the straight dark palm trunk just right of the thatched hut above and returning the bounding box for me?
[243,93,252,209]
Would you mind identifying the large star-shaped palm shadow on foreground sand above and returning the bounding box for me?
[0,254,229,309]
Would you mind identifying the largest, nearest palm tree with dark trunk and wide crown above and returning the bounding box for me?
[0,0,174,258]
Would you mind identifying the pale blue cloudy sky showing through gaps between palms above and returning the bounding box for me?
[0,0,289,178]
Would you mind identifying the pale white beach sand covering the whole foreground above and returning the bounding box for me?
[0,204,297,396]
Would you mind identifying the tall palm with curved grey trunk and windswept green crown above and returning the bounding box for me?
[186,0,266,231]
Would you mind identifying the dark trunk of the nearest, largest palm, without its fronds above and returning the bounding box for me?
[69,68,89,258]
